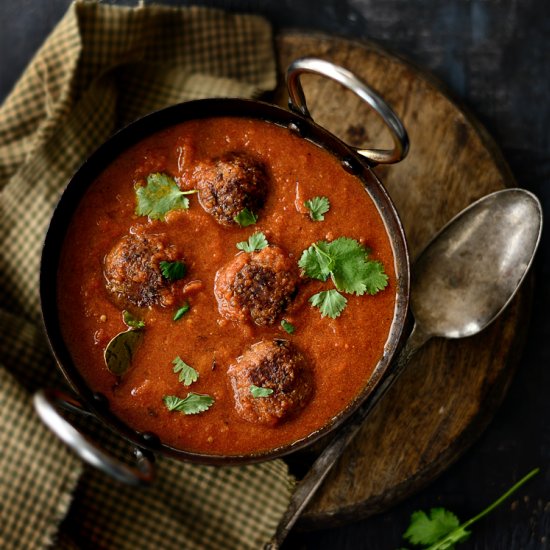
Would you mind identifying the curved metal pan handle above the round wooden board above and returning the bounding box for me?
[286,57,409,164]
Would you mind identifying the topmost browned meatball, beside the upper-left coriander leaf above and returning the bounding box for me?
[193,153,267,225]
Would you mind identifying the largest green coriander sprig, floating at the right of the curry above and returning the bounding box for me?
[298,237,388,319]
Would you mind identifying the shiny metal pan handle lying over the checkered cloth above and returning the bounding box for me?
[33,389,155,485]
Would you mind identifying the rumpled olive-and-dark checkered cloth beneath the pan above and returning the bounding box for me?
[0,2,293,550]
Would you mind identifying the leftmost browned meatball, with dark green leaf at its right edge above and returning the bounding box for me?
[104,230,187,307]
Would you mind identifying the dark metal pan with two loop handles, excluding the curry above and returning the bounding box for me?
[34,58,409,484]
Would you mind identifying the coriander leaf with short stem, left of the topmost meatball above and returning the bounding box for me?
[136,173,197,220]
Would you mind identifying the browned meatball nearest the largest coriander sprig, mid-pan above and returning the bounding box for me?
[214,246,299,326]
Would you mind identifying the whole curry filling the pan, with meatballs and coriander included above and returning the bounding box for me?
[57,117,396,456]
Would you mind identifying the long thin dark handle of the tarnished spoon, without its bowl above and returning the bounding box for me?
[264,323,430,550]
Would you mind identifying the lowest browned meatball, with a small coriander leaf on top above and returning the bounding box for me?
[227,340,313,426]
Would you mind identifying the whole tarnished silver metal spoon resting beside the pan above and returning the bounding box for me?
[266,189,542,550]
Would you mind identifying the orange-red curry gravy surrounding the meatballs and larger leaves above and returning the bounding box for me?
[58,117,396,455]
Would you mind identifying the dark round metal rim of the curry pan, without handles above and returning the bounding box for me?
[39,98,410,465]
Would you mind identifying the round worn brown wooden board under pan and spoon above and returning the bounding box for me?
[277,32,531,529]
